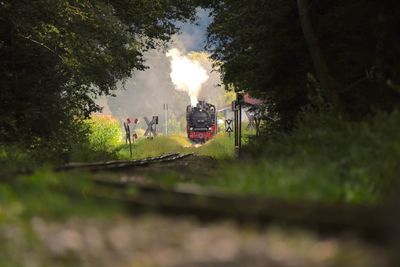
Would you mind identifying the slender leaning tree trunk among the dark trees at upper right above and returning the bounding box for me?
[297,0,340,111]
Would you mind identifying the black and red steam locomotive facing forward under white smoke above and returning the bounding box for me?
[186,101,217,143]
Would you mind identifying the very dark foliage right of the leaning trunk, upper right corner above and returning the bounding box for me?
[312,0,400,118]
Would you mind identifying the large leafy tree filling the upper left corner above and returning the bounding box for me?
[0,0,195,148]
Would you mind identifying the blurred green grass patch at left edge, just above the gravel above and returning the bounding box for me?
[0,169,120,224]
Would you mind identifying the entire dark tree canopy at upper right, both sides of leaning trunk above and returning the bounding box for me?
[205,0,400,129]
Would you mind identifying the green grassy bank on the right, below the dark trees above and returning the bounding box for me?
[211,112,400,203]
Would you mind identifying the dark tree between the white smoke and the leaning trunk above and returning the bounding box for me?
[208,0,312,129]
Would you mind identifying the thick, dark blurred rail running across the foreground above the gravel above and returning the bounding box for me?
[86,176,397,241]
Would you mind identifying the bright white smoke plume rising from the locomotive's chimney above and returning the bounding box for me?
[166,48,209,106]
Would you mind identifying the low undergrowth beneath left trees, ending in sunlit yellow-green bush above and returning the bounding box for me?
[0,116,122,177]
